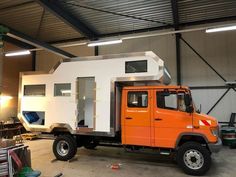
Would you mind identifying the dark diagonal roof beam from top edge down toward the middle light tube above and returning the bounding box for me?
[35,0,97,40]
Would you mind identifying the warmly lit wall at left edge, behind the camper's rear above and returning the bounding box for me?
[0,42,32,121]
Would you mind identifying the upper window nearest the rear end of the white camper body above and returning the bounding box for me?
[24,85,46,96]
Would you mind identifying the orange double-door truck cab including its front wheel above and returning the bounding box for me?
[121,86,221,175]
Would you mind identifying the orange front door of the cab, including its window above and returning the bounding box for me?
[152,89,192,148]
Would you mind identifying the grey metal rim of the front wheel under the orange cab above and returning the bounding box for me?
[183,149,204,170]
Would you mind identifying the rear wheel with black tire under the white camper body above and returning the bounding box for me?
[53,135,77,161]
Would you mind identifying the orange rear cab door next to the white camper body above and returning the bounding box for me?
[122,90,151,146]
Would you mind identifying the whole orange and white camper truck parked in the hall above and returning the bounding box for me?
[18,52,221,175]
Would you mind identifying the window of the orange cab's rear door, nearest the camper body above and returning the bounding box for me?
[128,91,148,108]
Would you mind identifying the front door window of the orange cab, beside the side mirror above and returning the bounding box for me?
[156,92,186,112]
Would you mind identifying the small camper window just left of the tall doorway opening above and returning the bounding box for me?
[54,83,71,96]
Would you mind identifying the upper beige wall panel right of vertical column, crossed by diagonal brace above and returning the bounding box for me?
[181,31,236,86]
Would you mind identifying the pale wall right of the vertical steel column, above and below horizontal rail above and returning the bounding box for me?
[181,31,236,121]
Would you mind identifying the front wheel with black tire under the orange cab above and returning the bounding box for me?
[177,142,211,176]
